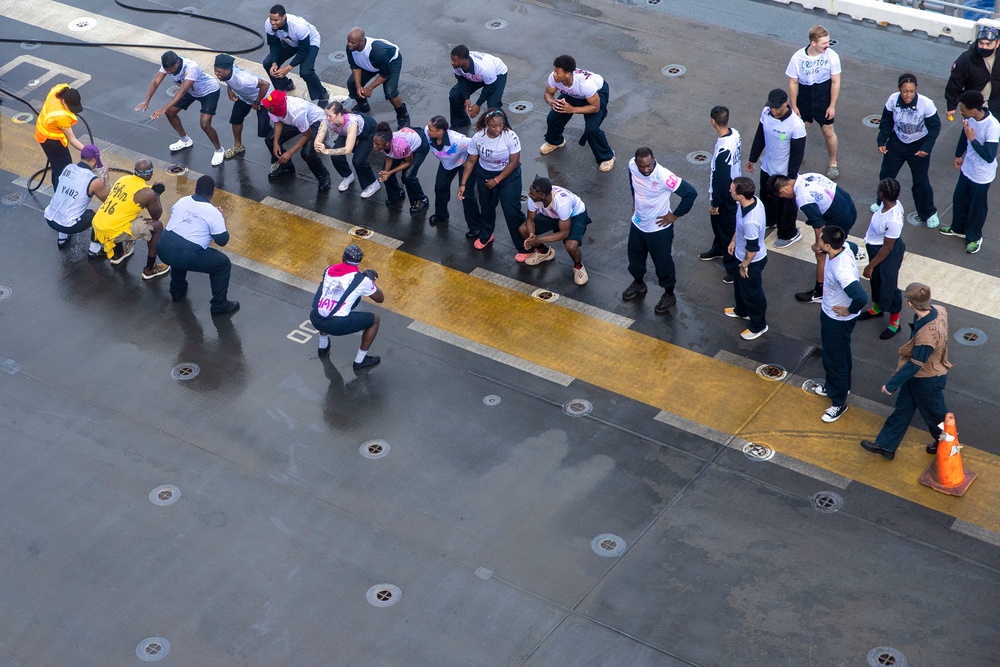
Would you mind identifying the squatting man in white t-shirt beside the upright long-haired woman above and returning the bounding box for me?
[520,176,590,285]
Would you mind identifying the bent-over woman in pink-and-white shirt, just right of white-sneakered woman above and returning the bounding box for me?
[372,121,430,215]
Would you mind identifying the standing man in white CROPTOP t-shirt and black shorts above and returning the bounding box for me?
[785,25,840,180]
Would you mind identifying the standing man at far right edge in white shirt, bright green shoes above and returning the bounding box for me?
[938,90,1000,255]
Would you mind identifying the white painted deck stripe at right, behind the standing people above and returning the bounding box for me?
[767,220,1000,317]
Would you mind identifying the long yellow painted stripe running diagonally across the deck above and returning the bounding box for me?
[0,123,1000,533]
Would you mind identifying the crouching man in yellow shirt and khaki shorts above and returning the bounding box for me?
[88,160,170,280]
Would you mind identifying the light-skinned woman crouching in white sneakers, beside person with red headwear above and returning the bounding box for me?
[314,101,382,199]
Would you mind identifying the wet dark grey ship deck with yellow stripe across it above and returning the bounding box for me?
[0,0,1000,667]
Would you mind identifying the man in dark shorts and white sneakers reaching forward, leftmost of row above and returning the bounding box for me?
[135,51,226,167]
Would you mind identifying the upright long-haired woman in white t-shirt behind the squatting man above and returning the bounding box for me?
[458,109,531,254]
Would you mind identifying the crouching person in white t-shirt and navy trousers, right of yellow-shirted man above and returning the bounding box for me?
[156,176,240,315]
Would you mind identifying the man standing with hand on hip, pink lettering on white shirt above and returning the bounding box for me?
[622,146,698,315]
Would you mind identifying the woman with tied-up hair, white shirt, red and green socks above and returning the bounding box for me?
[858,178,906,340]
